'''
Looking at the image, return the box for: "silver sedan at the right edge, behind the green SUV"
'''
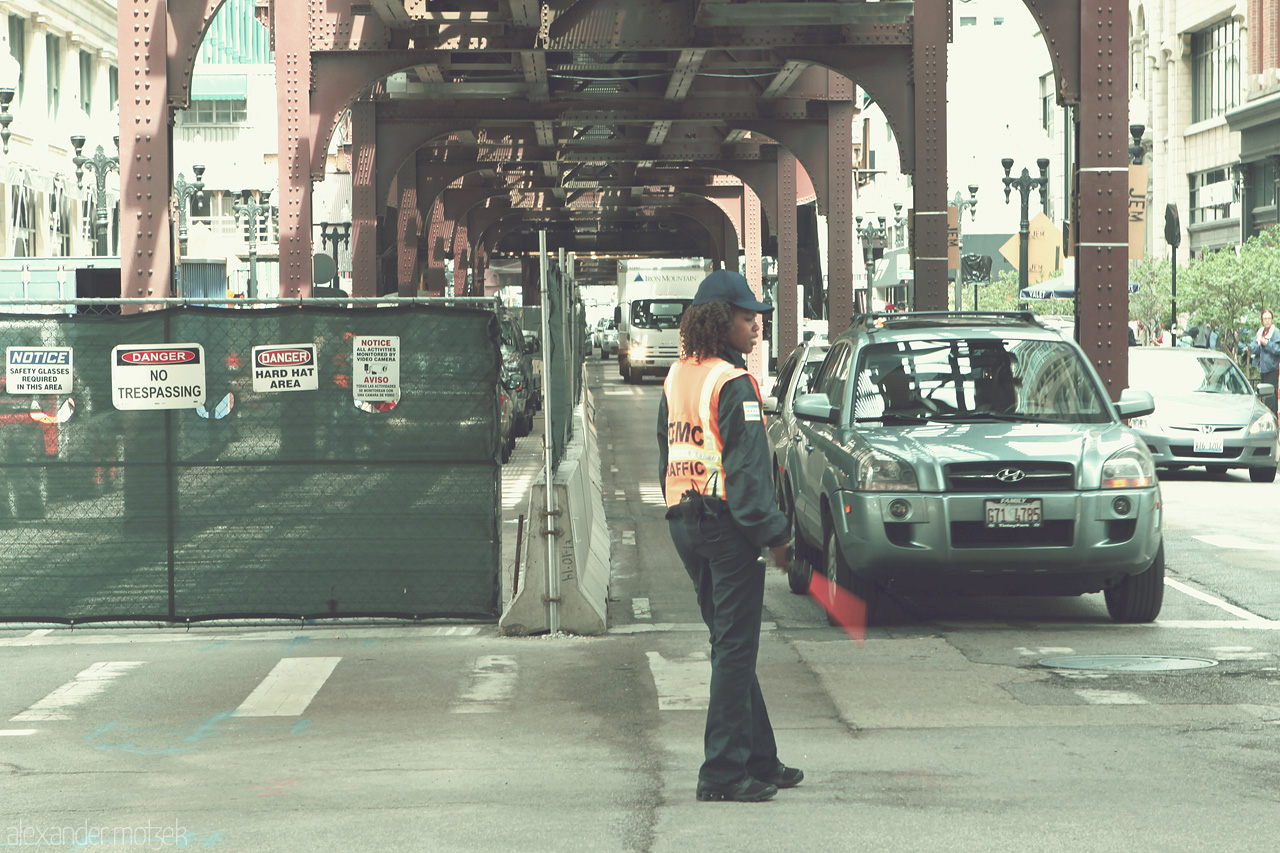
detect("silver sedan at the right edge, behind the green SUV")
[1129,347,1277,483]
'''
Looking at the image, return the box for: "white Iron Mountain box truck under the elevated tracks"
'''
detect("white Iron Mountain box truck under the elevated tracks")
[614,260,710,383]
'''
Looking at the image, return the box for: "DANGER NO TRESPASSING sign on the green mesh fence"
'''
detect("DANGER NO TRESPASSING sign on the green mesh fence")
[111,343,205,410]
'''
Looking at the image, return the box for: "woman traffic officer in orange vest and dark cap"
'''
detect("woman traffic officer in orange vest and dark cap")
[658,270,804,803]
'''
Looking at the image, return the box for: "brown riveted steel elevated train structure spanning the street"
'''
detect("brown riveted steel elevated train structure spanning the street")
[119,0,1128,398]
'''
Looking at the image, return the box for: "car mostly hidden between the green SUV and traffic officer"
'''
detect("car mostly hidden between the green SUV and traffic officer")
[764,337,828,594]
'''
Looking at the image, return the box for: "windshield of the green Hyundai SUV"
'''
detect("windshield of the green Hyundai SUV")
[851,338,1114,424]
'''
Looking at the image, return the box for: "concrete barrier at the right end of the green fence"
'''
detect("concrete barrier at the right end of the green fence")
[498,389,609,637]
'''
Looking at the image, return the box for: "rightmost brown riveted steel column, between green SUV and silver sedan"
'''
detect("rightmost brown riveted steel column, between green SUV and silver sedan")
[1075,1,1129,400]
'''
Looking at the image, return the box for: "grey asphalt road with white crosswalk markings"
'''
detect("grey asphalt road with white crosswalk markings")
[0,360,1280,853]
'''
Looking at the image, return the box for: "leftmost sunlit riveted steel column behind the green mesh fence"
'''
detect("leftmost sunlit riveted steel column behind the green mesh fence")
[116,0,173,311]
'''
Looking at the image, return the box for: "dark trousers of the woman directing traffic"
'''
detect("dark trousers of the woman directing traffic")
[669,519,778,784]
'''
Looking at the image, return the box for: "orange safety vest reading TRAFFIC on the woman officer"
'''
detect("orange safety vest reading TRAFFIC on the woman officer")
[663,359,760,507]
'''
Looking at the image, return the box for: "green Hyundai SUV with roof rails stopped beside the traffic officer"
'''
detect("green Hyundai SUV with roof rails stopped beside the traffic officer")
[791,311,1165,622]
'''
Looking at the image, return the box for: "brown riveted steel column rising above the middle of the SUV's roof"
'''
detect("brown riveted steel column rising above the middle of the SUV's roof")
[911,0,951,311]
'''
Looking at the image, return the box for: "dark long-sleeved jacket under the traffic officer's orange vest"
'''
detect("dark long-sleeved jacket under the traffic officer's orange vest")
[658,351,791,547]
